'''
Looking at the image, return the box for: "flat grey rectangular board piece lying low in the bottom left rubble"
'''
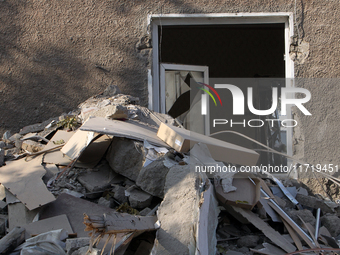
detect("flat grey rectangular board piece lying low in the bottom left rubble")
[23,214,73,239]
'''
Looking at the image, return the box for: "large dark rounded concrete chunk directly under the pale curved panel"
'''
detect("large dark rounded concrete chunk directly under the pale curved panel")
[106,137,145,181]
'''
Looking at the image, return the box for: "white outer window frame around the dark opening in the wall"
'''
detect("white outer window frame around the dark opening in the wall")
[148,12,294,156]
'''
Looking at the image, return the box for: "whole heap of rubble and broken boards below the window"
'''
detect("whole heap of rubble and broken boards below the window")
[0,86,340,255]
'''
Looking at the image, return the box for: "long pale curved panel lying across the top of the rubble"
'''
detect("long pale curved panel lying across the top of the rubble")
[80,118,169,148]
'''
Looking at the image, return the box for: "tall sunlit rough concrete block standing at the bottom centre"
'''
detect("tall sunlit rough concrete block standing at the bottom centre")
[153,165,199,255]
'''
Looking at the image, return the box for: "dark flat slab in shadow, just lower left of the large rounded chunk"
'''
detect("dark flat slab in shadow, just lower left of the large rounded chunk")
[77,161,122,192]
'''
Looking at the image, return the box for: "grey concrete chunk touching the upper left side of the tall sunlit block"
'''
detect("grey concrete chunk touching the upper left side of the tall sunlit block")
[136,157,169,198]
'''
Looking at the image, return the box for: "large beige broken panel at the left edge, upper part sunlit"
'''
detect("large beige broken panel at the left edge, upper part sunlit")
[0,156,55,210]
